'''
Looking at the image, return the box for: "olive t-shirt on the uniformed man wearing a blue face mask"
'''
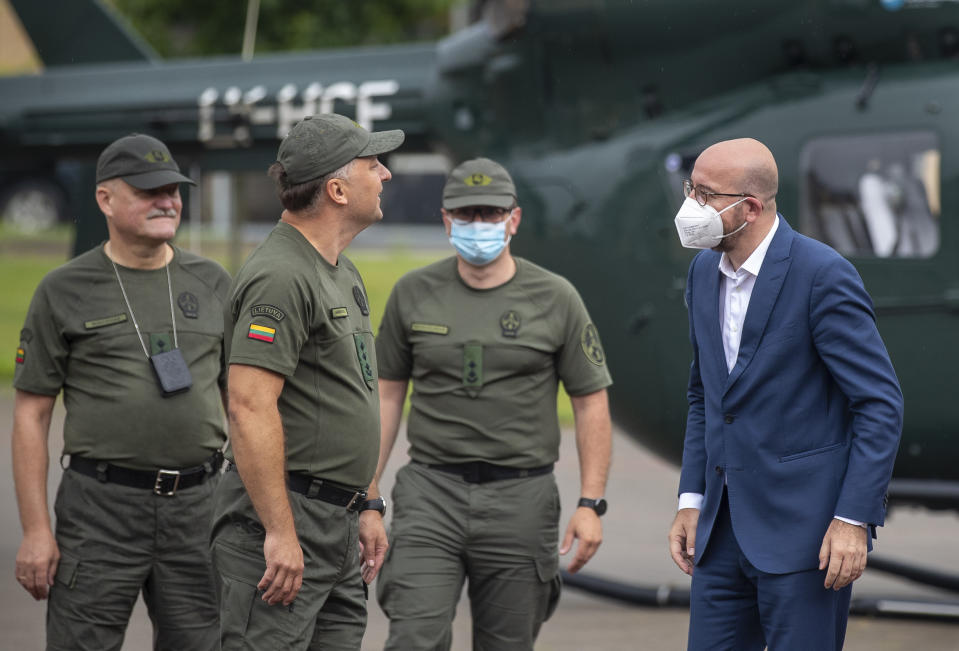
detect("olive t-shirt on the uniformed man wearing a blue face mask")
[376,257,612,468]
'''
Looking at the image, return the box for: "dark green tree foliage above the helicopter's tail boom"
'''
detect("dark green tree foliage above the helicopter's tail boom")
[107,0,465,57]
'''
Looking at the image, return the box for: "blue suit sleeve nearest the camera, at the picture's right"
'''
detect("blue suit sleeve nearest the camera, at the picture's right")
[809,258,903,526]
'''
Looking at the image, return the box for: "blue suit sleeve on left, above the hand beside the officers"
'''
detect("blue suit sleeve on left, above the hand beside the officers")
[679,256,706,494]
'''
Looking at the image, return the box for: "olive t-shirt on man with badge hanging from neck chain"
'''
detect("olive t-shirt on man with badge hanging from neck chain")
[13,245,230,469]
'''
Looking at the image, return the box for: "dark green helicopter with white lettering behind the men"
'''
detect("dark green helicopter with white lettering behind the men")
[0,0,959,509]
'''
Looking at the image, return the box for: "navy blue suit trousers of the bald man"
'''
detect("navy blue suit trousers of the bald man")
[689,490,852,651]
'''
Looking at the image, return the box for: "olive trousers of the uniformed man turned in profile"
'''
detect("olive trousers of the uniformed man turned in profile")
[212,472,366,651]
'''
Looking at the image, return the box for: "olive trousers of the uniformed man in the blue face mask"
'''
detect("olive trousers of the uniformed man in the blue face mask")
[377,463,560,651]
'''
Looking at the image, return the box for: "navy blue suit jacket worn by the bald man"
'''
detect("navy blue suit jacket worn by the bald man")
[679,215,903,574]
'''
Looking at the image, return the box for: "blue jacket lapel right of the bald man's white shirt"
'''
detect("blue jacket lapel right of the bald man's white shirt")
[720,215,795,393]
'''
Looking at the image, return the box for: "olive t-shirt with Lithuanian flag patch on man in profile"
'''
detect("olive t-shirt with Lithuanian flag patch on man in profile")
[226,222,380,488]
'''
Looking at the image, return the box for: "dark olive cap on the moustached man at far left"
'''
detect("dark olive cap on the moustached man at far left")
[97,133,196,190]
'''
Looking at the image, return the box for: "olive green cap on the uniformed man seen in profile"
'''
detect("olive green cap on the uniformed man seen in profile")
[276,113,406,185]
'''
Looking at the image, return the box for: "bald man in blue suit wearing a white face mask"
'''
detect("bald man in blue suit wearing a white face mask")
[669,139,902,651]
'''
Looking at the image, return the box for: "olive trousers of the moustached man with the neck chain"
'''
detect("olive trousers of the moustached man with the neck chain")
[47,470,218,651]
